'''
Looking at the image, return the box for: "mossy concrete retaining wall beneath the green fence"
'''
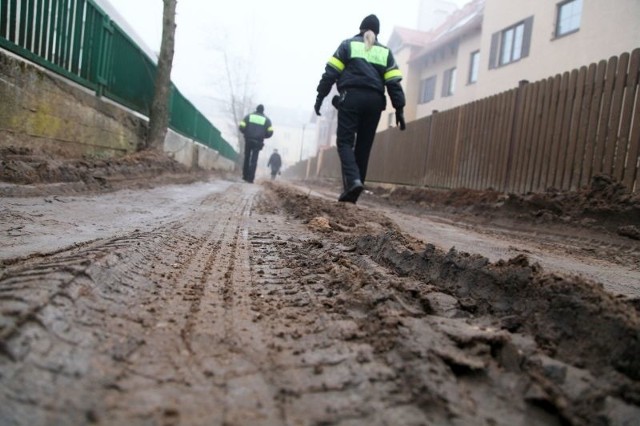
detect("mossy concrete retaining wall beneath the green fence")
[0,49,234,175]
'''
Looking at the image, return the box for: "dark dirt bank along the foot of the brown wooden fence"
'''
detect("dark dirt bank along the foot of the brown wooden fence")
[372,175,640,240]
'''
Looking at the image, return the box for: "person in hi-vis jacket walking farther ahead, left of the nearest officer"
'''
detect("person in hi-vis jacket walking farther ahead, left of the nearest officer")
[239,105,273,183]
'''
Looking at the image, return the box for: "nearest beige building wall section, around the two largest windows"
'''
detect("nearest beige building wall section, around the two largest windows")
[477,0,640,97]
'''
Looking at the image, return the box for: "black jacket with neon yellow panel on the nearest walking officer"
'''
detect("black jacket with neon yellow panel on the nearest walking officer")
[318,35,405,109]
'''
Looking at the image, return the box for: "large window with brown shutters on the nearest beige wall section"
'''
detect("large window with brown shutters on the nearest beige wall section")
[489,16,533,69]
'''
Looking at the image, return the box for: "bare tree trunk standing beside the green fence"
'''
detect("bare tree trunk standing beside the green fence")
[147,0,178,149]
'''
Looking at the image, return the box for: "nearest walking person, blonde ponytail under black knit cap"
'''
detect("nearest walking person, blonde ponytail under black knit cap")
[314,15,405,203]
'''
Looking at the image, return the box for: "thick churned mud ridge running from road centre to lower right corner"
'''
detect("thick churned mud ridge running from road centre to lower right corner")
[268,184,640,424]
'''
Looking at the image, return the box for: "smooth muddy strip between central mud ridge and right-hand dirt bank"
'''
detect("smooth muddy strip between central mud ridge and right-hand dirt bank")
[295,183,640,298]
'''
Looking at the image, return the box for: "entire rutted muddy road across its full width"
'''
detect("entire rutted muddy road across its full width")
[0,180,640,425]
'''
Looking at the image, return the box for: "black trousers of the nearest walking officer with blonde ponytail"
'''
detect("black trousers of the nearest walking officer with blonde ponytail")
[336,89,386,190]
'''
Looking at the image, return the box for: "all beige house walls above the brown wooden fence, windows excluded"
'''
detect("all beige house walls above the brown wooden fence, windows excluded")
[403,0,640,119]
